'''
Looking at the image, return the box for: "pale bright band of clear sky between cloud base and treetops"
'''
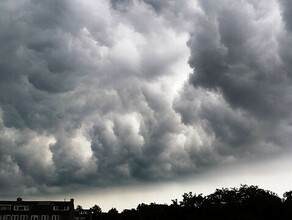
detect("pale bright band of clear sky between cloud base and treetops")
[12,152,292,212]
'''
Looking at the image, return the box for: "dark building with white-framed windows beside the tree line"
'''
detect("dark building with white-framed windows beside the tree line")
[0,198,74,220]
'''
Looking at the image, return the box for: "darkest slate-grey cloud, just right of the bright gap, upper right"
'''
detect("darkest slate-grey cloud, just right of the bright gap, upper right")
[188,1,291,117]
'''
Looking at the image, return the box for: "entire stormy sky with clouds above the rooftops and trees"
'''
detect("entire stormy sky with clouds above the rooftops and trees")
[0,0,292,211]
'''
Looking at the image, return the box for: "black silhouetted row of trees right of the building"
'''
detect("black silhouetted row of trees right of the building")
[82,185,292,220]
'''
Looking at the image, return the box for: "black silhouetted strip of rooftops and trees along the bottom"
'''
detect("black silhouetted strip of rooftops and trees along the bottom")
[0,185,292,220]
